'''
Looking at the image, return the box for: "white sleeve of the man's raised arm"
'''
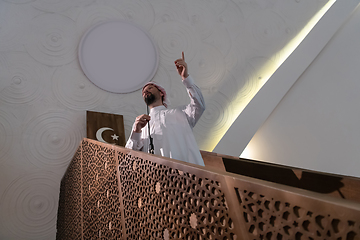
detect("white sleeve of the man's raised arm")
[183,76,205,128]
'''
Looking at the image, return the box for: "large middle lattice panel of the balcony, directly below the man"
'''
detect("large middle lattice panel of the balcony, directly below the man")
[118,153,235,239]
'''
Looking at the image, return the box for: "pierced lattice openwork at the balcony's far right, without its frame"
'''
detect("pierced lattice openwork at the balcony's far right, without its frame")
[235,188,360,240]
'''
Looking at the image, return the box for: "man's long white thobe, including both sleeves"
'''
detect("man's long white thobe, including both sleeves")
[125,76,205,166]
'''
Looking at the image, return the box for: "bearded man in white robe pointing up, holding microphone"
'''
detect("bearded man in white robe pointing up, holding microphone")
[125,53,205,166]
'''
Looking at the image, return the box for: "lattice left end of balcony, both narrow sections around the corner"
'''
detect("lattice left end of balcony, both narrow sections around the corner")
[57,141,122,239]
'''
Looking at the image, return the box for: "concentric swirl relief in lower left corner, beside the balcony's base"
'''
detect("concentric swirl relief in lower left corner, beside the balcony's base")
[1,171,60,239]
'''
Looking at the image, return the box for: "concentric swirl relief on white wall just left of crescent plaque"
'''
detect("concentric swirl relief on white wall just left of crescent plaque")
[22,111,85,168]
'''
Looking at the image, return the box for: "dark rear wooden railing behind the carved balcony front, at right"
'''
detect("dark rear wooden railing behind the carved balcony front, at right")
[201,151,360,203]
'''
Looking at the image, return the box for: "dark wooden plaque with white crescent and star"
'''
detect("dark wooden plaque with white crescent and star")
[86,111,125,147]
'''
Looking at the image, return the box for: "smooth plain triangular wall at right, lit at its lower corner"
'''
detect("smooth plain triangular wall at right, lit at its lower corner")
[242,2,360,177]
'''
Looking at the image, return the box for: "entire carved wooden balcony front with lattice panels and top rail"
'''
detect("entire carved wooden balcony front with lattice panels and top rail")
[57,139,360,240]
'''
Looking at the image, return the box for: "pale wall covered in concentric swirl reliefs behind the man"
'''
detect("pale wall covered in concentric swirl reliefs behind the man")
[0,0,327,240]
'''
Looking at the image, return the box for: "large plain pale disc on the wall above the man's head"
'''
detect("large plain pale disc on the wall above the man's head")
[79,20,159,93]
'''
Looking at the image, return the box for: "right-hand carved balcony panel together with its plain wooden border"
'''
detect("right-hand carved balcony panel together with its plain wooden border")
[229,180,360,240]
